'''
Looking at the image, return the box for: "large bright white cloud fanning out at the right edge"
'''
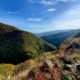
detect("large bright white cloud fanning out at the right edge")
[49,6,80,29]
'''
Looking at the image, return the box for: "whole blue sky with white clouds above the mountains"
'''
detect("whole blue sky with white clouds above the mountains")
[0,0,80,33]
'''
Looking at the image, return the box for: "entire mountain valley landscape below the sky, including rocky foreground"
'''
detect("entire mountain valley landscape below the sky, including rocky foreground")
[0,23,80,80]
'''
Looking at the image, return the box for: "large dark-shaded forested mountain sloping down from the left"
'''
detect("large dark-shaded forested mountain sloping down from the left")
[0,23,56,64]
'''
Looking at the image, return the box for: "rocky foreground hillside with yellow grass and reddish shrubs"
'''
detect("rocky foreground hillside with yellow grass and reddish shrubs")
[0,52,80,80]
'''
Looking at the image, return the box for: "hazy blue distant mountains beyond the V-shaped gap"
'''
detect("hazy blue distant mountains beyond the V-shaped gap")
[41,29,80,48]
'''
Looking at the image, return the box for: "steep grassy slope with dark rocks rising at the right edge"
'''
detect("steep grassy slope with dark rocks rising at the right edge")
[60,32,80,53]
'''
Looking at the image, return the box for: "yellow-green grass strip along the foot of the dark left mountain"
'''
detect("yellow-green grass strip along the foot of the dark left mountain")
[0,52,54,80]
